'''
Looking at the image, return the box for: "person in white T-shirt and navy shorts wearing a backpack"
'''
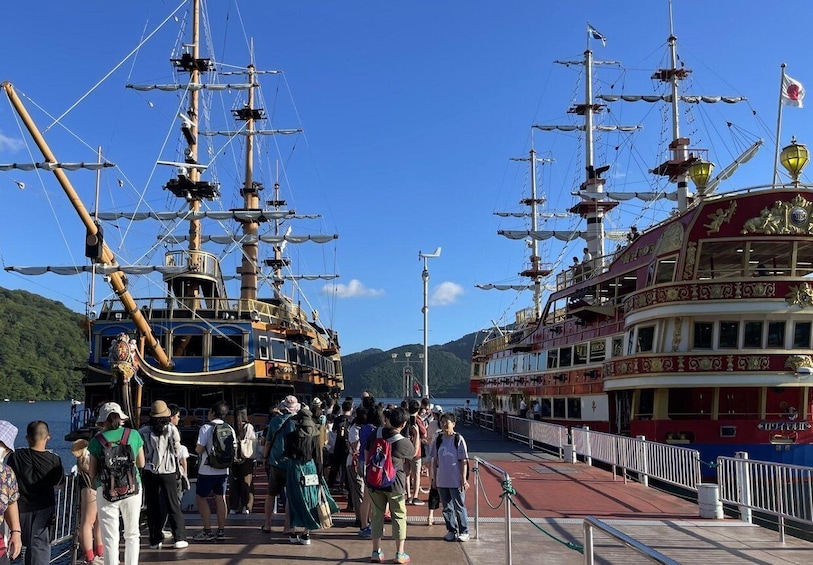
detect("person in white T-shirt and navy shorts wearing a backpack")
[192,400,237,541]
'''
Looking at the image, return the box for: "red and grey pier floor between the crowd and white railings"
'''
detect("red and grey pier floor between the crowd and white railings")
[140,426,813,565]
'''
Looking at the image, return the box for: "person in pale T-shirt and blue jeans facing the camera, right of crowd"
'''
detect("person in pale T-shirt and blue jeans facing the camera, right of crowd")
[431,412,469,542]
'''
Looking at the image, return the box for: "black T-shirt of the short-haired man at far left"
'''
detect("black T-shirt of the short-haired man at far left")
[7,448,65,512]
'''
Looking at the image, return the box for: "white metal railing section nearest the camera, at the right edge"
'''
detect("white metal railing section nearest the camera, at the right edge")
[717,452,813,543]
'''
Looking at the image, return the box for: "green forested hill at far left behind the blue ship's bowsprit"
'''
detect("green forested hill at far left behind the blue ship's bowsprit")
[0,288,88,400]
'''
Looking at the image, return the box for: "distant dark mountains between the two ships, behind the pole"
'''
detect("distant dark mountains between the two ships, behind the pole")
[342,333,477,398]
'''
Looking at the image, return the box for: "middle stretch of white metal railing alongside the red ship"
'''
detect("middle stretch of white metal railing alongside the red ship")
[570,426,701,492]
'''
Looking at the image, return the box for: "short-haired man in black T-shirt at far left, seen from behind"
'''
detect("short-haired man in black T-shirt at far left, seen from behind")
[8,420,65,565]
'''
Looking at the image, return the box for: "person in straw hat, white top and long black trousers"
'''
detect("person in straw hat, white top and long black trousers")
[139,400,189,549]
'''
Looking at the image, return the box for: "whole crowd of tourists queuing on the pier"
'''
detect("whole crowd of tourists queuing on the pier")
[0,393,469,565]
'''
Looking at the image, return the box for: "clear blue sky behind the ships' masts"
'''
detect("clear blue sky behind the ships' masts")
[0,0,813,353]
